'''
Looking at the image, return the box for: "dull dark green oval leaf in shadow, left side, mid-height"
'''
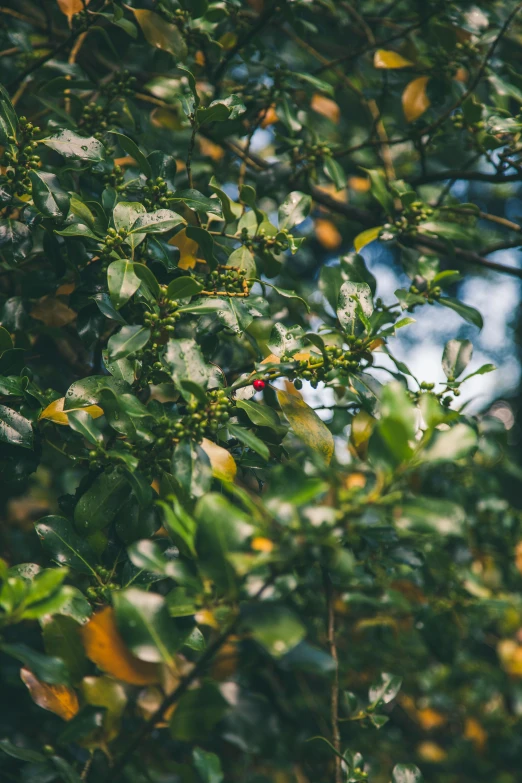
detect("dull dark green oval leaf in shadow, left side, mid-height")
[74,469,129,535]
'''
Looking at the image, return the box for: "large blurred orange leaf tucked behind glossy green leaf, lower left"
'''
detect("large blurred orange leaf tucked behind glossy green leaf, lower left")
[80,606,160,685]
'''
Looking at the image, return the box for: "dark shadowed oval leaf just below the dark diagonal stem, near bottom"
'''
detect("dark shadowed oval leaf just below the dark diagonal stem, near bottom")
[170,682,228,742]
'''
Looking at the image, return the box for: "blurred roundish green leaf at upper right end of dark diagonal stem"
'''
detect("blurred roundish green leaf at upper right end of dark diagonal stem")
[241,601,306,658]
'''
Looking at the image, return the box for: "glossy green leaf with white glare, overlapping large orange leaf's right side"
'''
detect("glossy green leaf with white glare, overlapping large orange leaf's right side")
[113,587,192,664]
